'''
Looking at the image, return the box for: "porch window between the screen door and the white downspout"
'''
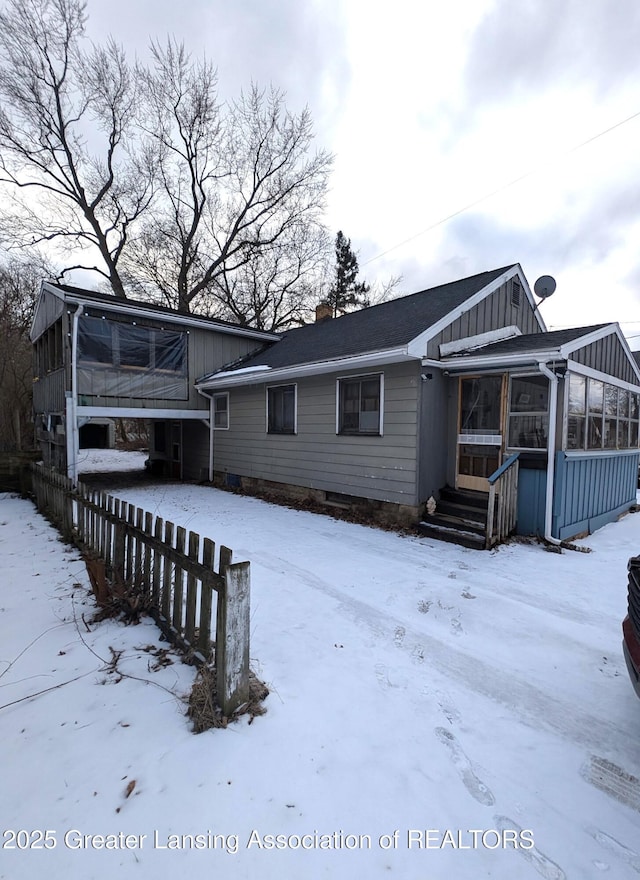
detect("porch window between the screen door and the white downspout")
[509,375,549,449]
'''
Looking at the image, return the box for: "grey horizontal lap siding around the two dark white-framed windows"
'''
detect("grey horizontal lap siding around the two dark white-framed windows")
[214,363,420,505]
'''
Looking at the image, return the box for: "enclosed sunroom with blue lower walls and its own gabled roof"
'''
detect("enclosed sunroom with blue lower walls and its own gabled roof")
[441,324,640,542]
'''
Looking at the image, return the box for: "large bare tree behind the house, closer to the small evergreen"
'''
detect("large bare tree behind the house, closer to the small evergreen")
[127,42,332,318]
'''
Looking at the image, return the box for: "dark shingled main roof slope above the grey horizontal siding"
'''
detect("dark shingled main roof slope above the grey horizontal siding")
[201,264,517,381]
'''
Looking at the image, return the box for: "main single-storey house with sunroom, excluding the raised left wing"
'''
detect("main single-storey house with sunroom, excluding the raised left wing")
[196,264,640,546]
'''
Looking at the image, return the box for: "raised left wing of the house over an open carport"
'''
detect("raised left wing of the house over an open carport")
[31,282,279,480]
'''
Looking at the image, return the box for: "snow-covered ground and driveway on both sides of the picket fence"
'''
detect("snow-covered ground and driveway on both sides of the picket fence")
[0,454,640,880]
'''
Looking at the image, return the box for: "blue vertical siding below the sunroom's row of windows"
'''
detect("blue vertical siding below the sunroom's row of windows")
[552,451,639,539]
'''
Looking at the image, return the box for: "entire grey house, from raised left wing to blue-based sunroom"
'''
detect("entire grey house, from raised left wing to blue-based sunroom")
[31,264,640,547]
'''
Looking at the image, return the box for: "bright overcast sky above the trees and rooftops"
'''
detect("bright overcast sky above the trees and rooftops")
[82,0,640,340]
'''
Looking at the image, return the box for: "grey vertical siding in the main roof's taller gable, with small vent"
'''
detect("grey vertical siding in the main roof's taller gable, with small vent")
[427,281,541,358]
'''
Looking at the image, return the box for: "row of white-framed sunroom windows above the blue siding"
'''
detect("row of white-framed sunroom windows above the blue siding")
[567,373,640,450]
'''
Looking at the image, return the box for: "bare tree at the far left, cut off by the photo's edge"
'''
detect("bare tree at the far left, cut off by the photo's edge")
[0,0,153,298]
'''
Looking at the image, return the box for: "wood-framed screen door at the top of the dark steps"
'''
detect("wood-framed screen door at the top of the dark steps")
[456,376,504,492]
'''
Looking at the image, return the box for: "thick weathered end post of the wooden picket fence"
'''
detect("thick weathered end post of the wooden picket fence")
[216,562,251,717]
